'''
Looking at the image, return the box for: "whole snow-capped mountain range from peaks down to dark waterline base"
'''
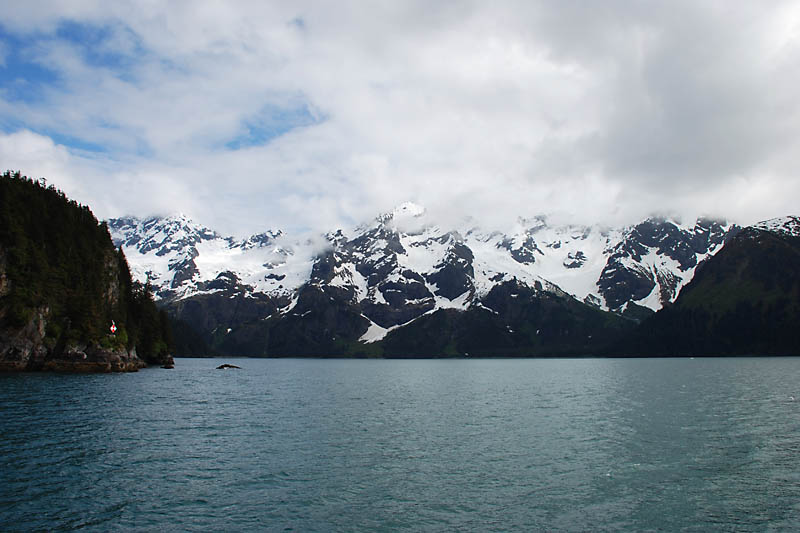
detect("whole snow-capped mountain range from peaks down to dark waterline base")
[108,203,764,356]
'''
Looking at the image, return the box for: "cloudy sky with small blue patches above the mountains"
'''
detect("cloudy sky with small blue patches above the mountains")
[0,0,800,236]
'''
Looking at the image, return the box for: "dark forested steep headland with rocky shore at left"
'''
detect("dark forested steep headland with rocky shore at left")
[0,172,171,371]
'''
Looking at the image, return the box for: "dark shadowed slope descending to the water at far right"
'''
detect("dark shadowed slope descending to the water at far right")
[618,217,800,356]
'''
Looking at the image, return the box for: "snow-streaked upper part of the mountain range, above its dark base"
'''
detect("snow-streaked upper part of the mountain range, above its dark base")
[109,203,738,352]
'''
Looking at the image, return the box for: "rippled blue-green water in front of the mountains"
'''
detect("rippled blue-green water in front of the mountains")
[0,358,800,532]
